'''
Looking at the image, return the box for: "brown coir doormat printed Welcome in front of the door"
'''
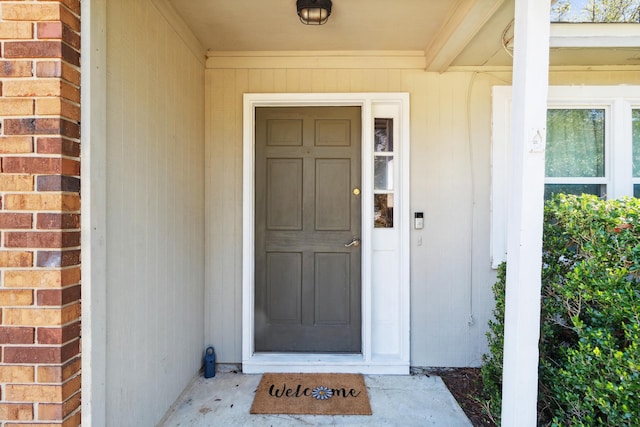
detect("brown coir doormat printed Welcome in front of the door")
[251,374,371,415]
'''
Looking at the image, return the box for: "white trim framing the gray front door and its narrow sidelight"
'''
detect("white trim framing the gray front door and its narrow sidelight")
[242,93,410,374]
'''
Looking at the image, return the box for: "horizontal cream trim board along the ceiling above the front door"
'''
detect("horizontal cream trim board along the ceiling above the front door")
[206,50,425,70]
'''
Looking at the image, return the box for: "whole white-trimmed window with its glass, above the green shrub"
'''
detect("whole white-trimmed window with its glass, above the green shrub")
[491,86,640,267]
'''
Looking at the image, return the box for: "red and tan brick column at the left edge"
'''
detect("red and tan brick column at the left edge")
[0,0,80,426]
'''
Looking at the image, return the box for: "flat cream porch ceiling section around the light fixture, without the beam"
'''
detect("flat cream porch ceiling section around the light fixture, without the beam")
[170,0,460,51]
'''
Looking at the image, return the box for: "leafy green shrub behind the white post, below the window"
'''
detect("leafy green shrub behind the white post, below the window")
[482,195,640,426]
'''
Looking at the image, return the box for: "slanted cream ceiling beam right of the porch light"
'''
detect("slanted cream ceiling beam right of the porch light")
[425,0,504,72]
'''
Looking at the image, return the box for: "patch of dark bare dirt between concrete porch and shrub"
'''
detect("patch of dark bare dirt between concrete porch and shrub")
[434,368,496,427]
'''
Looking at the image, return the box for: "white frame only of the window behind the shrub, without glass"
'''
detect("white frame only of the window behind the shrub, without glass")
[491,85,640,268]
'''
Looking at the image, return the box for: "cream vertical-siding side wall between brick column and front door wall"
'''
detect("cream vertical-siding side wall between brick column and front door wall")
[106,0,204,425]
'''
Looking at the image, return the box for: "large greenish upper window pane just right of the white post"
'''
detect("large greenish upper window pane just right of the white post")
[545,109,605,177]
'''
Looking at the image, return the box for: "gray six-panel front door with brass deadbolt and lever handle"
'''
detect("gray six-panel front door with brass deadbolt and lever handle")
[255,107,361,353]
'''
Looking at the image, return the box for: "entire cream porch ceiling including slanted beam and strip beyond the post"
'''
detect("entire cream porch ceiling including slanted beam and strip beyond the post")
[168,0,640,71]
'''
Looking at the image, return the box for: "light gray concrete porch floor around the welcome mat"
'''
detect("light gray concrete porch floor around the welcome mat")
[161,372,471,427]
